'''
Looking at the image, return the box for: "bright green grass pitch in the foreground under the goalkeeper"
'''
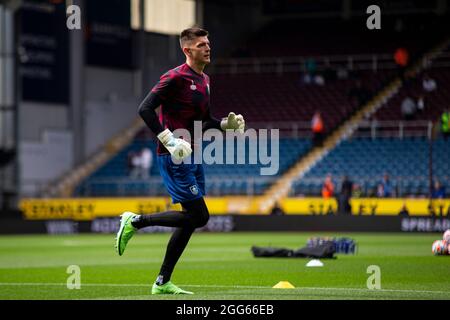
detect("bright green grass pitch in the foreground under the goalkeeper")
[0,233,450,300]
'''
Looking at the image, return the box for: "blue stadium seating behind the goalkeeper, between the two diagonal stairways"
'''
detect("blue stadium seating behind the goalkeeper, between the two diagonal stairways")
[76,135,311,196]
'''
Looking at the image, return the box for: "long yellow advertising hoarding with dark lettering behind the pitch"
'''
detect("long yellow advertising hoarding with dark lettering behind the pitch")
[20,197,450,221]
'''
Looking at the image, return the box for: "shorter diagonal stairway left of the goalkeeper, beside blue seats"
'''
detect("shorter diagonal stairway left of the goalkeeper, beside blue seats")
[43,118,145,197]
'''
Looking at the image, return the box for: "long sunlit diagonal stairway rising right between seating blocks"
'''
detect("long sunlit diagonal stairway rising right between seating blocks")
[253,39,450,213]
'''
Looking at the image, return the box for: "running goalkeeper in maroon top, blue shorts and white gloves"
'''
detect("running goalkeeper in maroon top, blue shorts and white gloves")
[116,28,245,294]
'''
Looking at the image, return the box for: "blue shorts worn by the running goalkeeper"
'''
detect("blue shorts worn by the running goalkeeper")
[157,154,205,203]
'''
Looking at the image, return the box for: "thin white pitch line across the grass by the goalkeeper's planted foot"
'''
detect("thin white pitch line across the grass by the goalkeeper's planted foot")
[0,282,450,294]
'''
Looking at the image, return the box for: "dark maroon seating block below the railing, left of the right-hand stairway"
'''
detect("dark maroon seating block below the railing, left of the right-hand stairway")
[211,71,392,132]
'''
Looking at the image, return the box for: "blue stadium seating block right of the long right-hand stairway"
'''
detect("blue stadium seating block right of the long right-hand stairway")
[292,137,450,197]
